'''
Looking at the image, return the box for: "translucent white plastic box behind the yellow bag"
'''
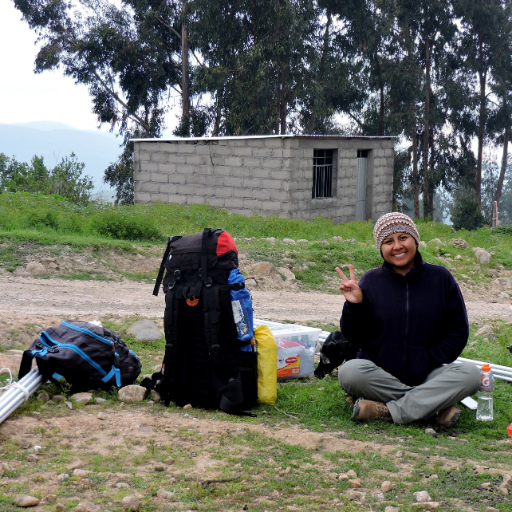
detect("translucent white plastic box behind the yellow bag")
[254,318,322,380]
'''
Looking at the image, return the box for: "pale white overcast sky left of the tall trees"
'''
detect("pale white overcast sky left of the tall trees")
[0,0,180,131]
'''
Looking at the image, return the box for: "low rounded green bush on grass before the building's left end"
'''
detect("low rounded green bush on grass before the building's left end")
[92,210,164,242]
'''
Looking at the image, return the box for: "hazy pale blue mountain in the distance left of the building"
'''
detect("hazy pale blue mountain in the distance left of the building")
[0,121,122,197]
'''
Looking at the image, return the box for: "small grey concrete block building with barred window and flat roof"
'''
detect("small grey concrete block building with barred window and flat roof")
[134,135,396,223]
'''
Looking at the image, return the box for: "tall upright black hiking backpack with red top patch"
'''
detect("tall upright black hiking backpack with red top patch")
[147,228,258,414]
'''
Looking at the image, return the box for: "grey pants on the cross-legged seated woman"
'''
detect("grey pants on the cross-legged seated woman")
[338,359,480,423]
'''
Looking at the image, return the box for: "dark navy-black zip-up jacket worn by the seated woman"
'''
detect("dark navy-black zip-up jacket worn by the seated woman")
[341,252,469,386]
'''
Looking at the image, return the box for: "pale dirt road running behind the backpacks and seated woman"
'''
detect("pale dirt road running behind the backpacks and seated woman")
[0,274,512,323]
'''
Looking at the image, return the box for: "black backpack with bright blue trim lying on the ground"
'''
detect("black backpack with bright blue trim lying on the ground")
[19,321,141,391]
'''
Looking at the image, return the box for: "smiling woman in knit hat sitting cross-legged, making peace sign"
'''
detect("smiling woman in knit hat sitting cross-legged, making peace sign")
[336,212,480,427]
